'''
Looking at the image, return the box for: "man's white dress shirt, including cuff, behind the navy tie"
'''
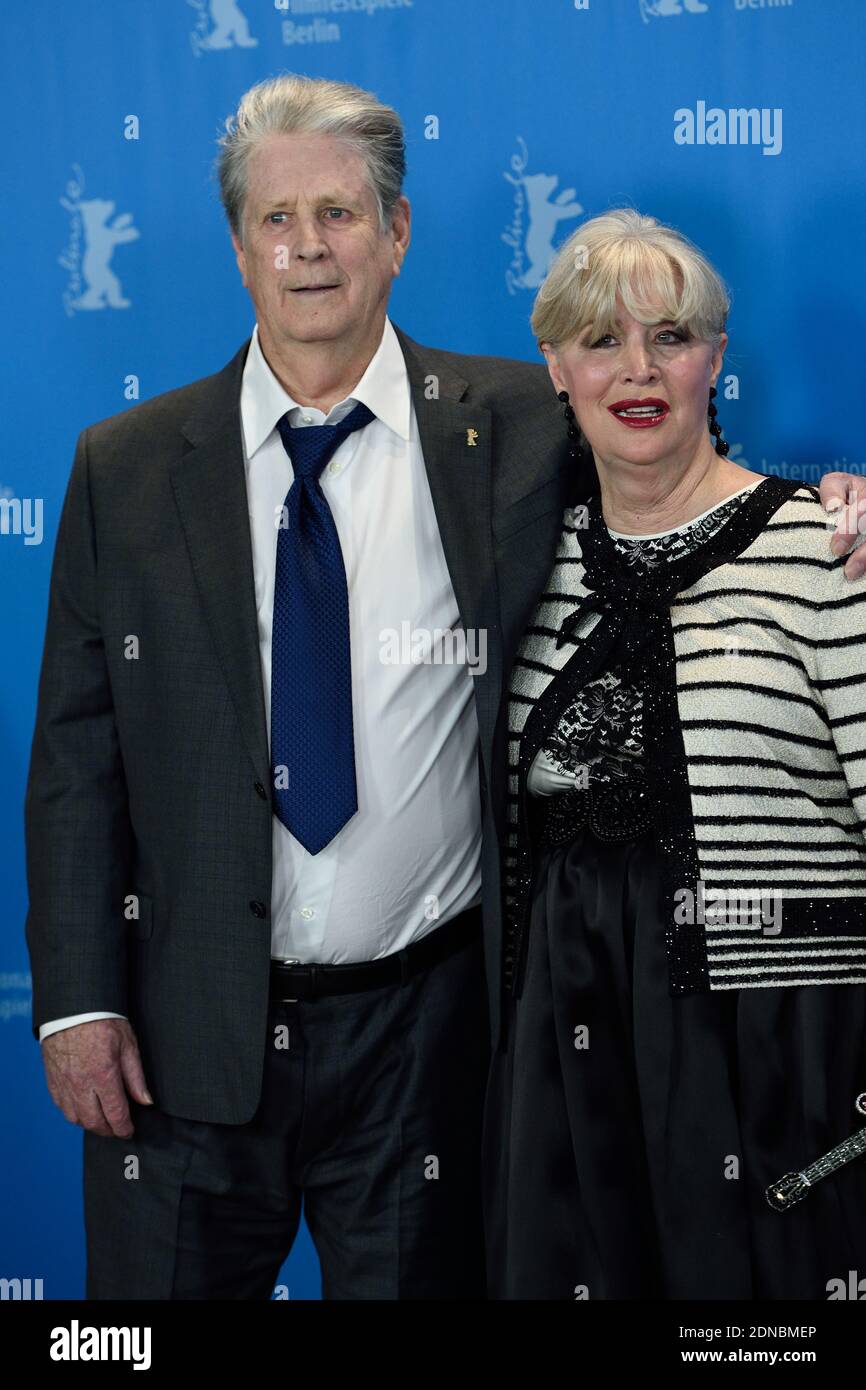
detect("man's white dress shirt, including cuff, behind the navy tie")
[39,320,481,1041]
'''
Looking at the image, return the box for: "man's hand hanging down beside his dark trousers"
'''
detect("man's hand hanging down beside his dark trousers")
[40,1019,153,1138]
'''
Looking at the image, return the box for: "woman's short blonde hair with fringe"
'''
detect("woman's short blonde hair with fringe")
[530,207,731,348]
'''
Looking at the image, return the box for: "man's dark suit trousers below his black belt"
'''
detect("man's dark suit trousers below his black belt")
[83,917,489,1300]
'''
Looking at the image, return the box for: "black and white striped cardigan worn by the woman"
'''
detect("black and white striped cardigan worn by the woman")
[503,478,866,994]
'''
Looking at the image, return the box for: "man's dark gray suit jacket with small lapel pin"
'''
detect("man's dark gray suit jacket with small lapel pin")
[25,329,584,1125]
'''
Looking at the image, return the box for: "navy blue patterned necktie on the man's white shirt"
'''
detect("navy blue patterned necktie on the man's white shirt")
[271,403,375,855]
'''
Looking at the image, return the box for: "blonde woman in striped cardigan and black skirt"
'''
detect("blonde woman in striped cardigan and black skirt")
[484,210,866,1298]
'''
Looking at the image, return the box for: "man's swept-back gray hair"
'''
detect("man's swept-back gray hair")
[217,72,406,242]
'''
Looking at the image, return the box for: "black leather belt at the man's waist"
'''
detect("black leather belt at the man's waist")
[271,908,481,1004]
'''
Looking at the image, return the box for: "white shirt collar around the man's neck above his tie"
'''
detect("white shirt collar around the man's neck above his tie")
[240,318,410,459]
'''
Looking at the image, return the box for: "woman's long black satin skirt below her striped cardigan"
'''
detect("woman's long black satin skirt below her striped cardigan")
[484,831,866,1300]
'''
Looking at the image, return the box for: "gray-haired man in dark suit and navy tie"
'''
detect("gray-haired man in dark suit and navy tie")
[26,76,853,1298]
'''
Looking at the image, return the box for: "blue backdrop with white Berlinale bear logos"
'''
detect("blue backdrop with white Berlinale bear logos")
[0,0,866,1298]
